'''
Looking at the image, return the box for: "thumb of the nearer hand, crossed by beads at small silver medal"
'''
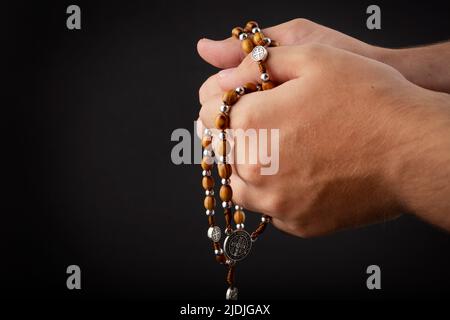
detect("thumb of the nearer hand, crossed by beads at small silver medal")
[216,46,308,91]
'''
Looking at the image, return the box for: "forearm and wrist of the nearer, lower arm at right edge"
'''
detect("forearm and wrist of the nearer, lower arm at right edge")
[392,90,450,231]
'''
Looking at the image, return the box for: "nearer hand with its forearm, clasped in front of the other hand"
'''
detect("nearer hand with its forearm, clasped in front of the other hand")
[199,19,450,237]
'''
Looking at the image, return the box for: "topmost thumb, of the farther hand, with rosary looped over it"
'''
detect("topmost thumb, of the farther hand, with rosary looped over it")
[197,19,306,69]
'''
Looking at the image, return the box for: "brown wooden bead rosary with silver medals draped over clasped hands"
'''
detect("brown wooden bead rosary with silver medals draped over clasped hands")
[201,21,278,300]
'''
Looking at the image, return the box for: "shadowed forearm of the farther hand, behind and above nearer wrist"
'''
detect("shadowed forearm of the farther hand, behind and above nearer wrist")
[378,41,450,93]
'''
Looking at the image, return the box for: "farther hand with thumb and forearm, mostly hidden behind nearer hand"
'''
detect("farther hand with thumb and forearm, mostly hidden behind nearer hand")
[197,18,450,93]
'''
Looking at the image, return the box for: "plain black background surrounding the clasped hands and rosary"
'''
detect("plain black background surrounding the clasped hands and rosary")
[6,0,450,300]
